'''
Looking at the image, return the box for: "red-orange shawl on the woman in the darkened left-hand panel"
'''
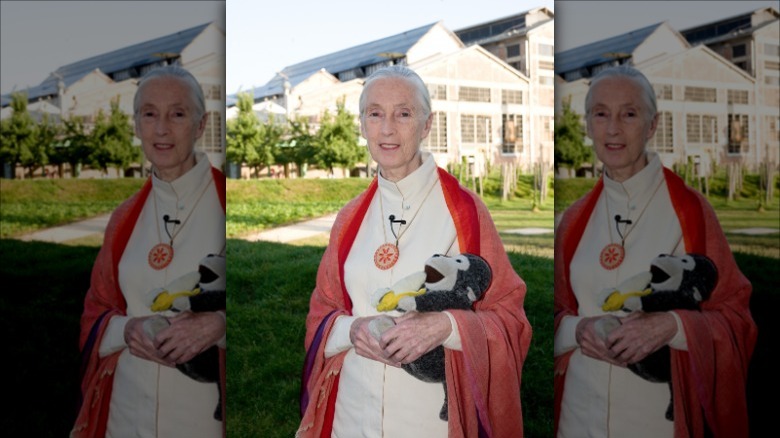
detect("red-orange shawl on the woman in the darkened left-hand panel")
[71,167,226,438]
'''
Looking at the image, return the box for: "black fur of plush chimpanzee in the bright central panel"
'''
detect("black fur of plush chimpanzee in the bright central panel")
[399,254,492,421]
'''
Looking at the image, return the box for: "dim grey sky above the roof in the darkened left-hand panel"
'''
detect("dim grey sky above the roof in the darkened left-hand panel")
[0,0,225,94]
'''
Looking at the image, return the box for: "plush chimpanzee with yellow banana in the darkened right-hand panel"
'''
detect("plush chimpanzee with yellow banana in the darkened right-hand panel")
[596,254,718,421]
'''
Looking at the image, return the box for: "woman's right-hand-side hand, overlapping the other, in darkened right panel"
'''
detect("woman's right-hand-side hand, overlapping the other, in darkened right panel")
[606,312,677,364]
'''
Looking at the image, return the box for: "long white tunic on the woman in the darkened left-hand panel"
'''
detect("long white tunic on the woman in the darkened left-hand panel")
[100,153,225,438]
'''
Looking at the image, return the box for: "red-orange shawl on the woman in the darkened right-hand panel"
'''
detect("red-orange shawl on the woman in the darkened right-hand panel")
[553,168,757,438]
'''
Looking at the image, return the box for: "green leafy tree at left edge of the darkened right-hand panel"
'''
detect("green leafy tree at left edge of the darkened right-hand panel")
[555,99,593,176]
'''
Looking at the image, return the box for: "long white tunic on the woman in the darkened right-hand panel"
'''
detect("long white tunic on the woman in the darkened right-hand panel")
[555,153,686,438]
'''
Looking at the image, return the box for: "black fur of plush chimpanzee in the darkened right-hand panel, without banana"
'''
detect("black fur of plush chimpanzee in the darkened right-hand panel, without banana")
[628,254,718,421]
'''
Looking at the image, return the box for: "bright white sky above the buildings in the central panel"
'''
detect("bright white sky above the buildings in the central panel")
[226,0,554,94]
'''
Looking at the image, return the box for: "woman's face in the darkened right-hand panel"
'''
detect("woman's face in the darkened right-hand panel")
[587,77,658,182]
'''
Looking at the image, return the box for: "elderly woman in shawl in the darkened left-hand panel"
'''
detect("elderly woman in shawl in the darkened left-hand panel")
[71,66,225,437]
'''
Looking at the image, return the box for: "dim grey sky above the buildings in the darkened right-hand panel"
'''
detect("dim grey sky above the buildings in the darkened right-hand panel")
[555,0,778,52]
